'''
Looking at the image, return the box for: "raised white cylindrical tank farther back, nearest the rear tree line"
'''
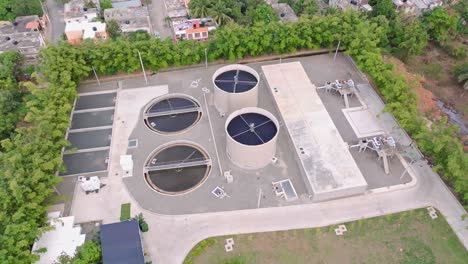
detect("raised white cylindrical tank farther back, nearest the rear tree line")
[213,64,260,115]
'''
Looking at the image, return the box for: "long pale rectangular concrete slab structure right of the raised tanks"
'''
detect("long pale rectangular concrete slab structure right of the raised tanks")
[262,62,367,201]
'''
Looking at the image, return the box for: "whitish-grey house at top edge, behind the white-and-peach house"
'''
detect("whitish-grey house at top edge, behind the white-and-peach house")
[63,0,100,24]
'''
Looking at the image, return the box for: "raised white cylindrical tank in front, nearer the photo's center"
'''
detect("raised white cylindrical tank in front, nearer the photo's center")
[225,107,279,169]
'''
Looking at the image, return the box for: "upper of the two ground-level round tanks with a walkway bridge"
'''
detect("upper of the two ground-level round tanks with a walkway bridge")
[144,94,202,134]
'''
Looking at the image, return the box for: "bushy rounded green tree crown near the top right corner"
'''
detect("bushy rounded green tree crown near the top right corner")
[422,7,457,43]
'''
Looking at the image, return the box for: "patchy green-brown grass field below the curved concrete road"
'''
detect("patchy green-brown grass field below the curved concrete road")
[184,209,468,264]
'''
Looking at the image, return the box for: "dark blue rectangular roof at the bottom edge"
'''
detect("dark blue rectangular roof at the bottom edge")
[101,220,145,264]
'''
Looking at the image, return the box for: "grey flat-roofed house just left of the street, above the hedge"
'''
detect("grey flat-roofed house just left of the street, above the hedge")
[104,7,153,34]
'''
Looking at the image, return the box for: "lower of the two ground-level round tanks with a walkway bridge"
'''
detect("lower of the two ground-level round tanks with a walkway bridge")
[144,142,211,195]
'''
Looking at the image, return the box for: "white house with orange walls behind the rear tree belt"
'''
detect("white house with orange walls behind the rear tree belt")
[172,18,216,41]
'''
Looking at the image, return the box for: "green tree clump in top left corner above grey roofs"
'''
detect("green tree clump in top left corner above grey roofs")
[0,0,42,21]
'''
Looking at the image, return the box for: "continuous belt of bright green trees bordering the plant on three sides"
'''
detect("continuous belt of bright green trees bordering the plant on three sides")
[0,0,468,264]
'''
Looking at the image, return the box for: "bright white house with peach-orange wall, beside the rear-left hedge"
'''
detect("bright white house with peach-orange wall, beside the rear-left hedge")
[65,21,107,44]
